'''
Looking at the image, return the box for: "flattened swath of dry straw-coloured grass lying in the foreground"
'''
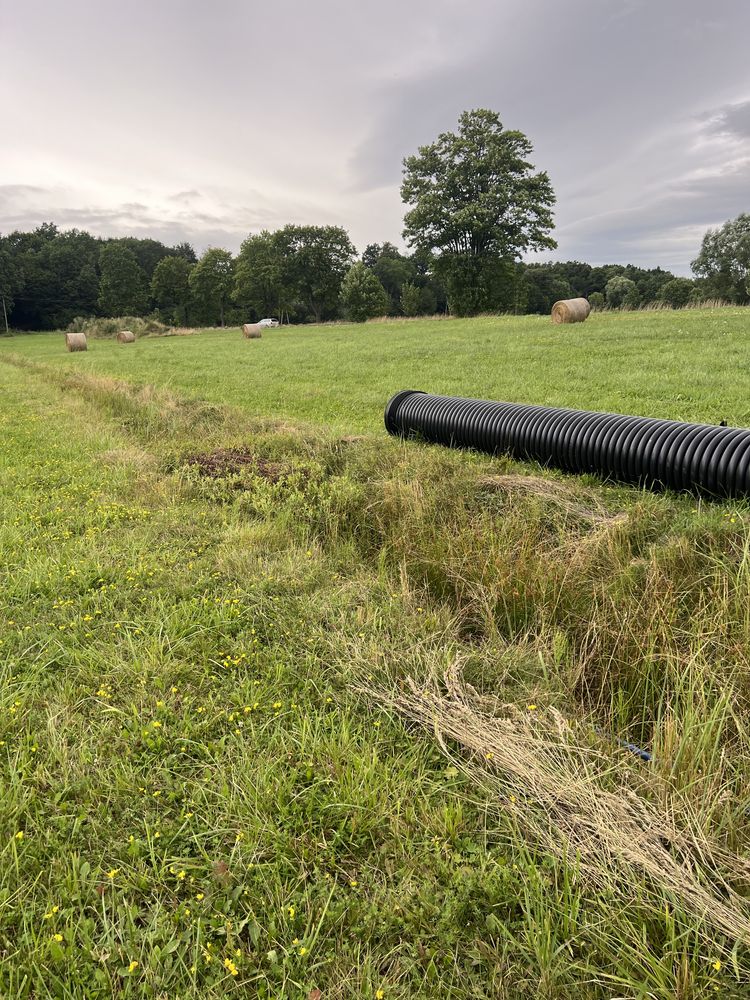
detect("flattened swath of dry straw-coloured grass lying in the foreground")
[361,664,750,943]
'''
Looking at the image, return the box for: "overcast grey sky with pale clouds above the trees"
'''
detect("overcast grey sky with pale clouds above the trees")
[0,0,750,273]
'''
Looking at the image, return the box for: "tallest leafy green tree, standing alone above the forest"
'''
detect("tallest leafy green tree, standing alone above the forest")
[401,109,557,314]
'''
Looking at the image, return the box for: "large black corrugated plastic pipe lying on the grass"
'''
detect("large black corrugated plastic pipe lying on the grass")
[385,389,750,497]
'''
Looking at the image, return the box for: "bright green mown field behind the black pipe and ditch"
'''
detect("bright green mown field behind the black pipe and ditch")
[5,308,750,432]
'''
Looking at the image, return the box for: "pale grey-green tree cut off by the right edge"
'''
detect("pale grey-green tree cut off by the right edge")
[691,212,750,303]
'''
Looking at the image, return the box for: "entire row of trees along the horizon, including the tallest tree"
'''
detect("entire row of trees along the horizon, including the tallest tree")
[0,109,750,330]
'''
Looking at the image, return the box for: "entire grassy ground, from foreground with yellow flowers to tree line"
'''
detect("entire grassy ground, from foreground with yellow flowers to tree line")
[0,309,750,1000]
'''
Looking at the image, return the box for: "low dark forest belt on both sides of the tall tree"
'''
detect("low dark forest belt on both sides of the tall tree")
[0,223,748,330]
